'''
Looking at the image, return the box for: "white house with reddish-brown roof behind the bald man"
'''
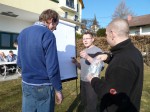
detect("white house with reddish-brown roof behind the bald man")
[128,14,150,36]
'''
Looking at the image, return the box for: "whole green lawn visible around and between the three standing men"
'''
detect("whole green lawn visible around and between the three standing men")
[0,66,150,112]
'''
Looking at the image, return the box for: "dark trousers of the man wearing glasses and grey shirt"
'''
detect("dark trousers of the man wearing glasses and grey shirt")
[80,81,98,112]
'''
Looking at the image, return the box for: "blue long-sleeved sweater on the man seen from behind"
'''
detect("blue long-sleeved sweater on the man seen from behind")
[17,25,62,91]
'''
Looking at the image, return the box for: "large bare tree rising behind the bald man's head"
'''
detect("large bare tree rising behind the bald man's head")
[112,0,134,19]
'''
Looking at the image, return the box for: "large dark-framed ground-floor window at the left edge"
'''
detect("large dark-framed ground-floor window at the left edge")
[0,32,19,49]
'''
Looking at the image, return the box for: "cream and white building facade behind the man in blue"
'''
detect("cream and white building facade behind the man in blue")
[0,0,84,51]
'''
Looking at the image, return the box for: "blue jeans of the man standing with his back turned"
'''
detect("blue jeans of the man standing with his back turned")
[22,83,55,112]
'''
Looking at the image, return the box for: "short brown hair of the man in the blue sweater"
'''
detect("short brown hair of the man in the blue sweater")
[39,9,59,23]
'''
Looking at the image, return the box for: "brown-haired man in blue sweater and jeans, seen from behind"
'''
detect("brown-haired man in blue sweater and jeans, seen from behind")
[17,9,63,112]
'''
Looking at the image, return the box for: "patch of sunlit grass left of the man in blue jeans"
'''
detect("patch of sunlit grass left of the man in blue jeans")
[0,79,22,112]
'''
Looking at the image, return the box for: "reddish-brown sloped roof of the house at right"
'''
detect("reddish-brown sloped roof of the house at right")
[128,14,150,27]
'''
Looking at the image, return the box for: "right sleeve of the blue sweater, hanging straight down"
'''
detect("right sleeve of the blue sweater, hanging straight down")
[43,34,62,91]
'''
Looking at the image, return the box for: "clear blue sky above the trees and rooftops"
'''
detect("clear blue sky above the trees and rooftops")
[82,0,150,28]
